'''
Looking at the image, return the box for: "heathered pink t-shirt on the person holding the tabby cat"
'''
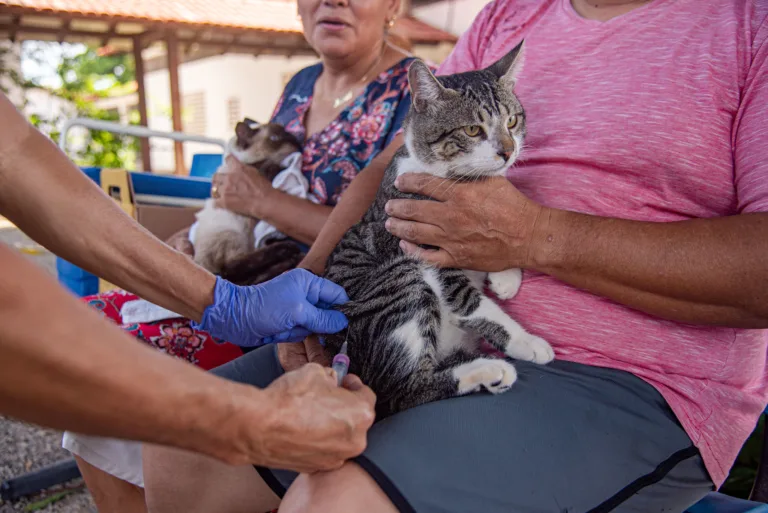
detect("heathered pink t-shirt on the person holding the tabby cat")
[439,0,768,486]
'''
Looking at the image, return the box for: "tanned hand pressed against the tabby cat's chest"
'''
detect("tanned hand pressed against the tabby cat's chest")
[386,173,545,272]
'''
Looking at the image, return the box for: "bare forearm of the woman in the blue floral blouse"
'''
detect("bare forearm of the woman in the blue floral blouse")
[254,190,333,245]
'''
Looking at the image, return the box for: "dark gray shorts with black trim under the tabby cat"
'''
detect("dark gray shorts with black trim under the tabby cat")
[214,347,713,513]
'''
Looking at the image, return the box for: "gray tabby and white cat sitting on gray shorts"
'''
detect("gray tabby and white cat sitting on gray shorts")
[326,43,554,415]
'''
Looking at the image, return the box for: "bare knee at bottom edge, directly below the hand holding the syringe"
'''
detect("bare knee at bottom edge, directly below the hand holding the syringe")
[280,462,397,513]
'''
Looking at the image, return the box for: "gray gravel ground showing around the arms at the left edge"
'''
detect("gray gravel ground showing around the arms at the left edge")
[0,223,96,513]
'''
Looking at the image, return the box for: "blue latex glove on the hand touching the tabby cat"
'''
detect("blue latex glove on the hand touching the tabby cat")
[192,269,349,347]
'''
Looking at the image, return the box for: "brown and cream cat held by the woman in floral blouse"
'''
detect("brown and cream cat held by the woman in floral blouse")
[193,118,301,281]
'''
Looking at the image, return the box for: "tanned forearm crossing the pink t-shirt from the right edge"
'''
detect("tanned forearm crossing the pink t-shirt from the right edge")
[532,210,768,328]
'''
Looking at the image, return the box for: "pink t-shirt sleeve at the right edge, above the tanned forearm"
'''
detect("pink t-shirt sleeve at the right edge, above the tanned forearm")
[733,20,768,213]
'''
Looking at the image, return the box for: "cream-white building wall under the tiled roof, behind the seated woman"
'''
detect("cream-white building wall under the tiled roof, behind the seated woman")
[145,54,316,172]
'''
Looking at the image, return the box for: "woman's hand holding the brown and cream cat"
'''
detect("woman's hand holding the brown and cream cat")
[212,156,274,219]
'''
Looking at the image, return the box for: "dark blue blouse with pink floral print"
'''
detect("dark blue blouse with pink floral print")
[272,58,413,206]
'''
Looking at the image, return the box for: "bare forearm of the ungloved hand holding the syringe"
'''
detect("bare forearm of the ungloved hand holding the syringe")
[0,245,260,457]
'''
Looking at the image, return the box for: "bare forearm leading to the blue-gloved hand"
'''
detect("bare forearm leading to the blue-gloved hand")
[0,96,215,320]
